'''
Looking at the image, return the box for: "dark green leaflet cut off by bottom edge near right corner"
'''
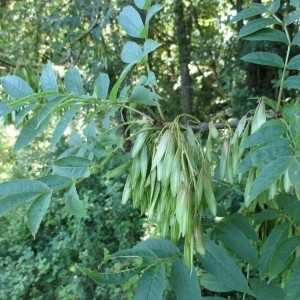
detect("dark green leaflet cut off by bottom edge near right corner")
[250,278,284,300]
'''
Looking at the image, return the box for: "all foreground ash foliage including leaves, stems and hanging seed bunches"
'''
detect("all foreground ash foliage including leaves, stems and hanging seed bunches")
[0,0,300,299]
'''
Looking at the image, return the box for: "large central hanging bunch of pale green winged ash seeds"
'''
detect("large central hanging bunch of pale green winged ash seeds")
[122,119,216,266]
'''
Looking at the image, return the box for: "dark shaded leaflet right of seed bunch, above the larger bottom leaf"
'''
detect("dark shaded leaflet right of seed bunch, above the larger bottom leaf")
[215,220,258,267]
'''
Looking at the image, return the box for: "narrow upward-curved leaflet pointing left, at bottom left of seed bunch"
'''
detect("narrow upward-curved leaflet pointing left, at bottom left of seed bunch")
[80,266,146,284]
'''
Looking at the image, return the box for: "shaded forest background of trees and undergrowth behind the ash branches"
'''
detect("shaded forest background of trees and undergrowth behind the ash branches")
[0,0,296,300]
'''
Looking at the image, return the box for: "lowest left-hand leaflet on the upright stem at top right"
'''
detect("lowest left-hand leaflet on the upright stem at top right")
[242,51,284,68]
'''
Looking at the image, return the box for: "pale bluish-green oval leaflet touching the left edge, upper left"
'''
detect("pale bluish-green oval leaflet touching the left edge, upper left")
[1,75,34,99]
